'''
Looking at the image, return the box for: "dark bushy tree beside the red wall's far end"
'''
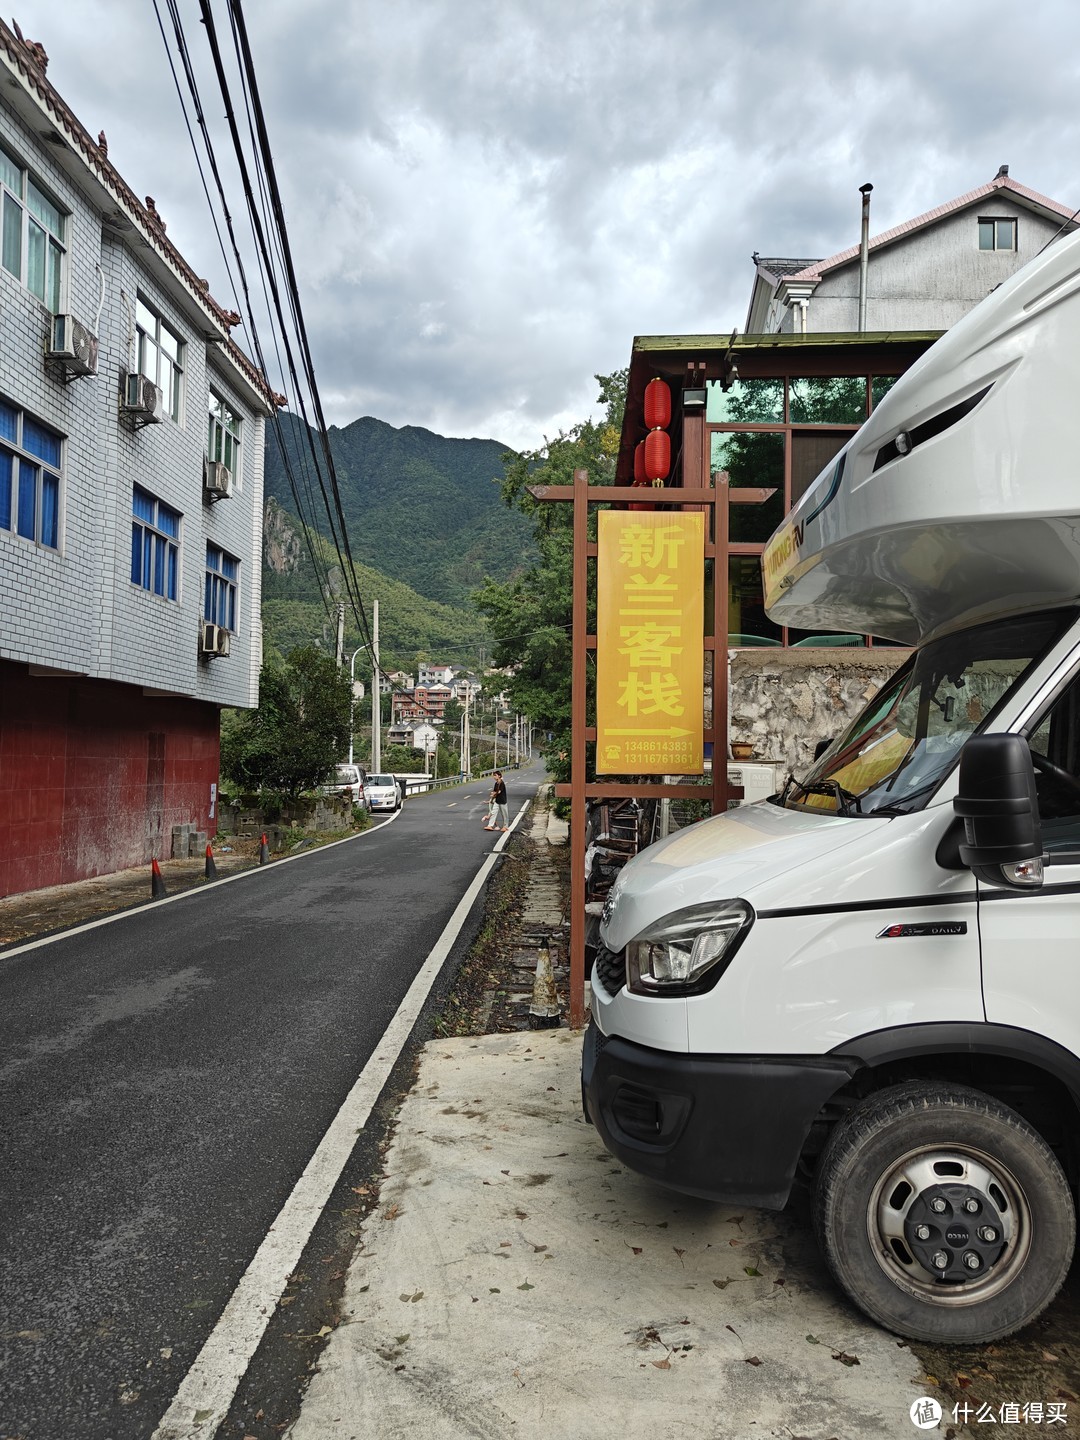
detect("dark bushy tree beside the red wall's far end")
[222,645,353,799]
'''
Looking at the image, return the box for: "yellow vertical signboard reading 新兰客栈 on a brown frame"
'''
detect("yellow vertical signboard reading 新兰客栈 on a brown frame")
[596,510,706,775]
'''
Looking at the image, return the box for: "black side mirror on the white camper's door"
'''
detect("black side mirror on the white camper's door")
[952,734,1044,890]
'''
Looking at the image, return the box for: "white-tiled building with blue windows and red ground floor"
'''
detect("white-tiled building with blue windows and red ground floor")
[0,23,274,894]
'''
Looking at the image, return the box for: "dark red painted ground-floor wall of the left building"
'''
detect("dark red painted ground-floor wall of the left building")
[0,660,219,896]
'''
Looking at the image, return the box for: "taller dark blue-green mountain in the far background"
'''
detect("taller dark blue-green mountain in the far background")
[265,415,536,608]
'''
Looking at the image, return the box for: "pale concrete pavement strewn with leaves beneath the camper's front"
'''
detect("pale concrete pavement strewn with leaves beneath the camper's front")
[289,1030,926,1440]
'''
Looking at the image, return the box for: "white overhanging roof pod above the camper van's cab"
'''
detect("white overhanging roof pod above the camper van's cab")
[762,232,1080,645]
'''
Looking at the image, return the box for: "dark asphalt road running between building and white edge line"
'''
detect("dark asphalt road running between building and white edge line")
[0,769,541,1440]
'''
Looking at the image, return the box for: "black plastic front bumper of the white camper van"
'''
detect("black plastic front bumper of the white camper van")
[582,1024,858,1210]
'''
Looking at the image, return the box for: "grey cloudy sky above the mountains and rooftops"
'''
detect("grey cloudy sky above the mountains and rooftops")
[13,0,1080,448]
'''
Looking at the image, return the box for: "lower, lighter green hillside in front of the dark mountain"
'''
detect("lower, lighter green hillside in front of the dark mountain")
[262,498,490,675]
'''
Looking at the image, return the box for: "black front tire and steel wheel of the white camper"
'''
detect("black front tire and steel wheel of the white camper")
[814,1083,1076,1345]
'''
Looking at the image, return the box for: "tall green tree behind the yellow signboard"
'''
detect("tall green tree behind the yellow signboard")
[475,370,628,780]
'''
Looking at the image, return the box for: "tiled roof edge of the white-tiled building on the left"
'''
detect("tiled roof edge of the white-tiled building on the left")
[0,20,285,406]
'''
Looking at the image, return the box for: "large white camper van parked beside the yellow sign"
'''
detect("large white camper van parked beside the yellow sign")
[582,218,1080,1344]
